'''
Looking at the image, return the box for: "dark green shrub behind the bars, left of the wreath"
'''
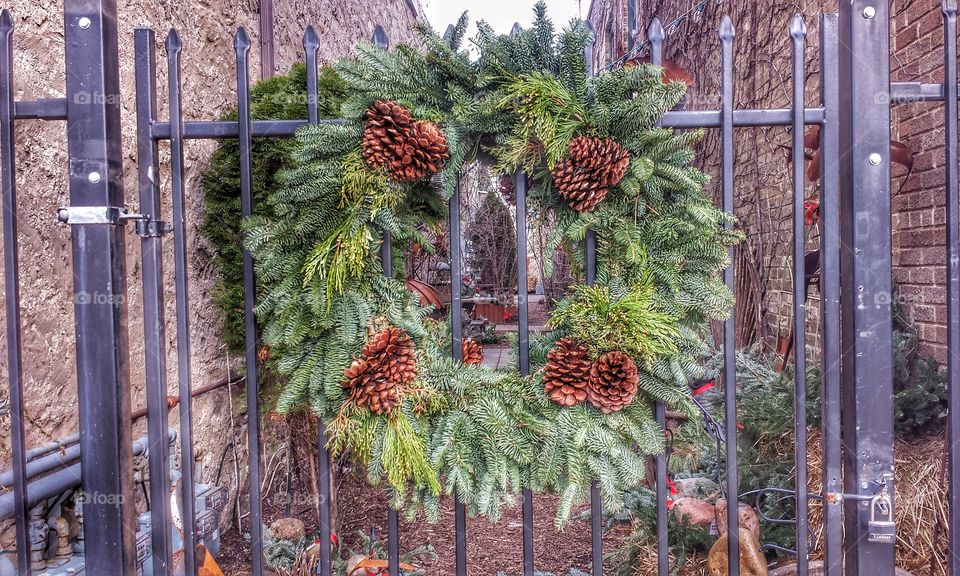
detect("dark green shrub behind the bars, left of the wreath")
[200,64,345,354]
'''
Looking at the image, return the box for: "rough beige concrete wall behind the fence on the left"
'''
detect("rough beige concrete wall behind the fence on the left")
[0,0,415,512]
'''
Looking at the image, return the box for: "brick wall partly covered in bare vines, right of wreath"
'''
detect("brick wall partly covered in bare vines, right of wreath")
[590,0,946,361]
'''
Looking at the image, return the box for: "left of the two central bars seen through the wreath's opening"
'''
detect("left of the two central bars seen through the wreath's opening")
[447,179,467,576]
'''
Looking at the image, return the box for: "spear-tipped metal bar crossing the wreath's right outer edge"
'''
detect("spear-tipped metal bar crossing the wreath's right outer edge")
[720,16,740,576]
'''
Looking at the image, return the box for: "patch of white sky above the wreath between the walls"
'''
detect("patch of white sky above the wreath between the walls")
[420,0,590,39]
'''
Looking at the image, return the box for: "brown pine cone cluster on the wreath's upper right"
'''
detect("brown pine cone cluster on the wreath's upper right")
[553,136,630,212]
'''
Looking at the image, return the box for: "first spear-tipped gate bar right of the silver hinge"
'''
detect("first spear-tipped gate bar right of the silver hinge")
[164,30,197,574]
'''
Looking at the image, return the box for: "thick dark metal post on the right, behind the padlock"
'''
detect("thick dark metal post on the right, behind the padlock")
[839,0,894,576]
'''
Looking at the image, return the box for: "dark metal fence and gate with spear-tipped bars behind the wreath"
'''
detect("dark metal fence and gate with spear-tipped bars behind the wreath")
[0,0,960,576]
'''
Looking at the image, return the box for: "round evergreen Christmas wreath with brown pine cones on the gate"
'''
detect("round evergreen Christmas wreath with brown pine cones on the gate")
[247,4,739,527]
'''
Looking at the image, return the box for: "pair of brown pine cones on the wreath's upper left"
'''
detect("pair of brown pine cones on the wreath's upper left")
[363,100,450,182]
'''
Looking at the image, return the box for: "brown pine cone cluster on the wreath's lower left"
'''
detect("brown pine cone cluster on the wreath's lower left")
[340,326,417,414]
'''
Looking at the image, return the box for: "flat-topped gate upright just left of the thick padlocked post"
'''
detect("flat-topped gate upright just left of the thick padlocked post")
[820,14,843,576]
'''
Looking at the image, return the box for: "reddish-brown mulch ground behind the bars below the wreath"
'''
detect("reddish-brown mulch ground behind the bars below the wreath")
[218,466,629,576]
